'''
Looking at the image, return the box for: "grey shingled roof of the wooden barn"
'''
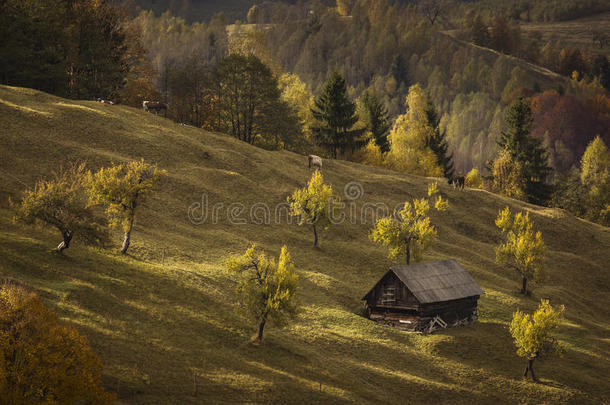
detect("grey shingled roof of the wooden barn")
[367,259,485,304]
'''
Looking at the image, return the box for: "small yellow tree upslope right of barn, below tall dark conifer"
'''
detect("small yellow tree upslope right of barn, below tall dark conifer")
[496,207,547,294]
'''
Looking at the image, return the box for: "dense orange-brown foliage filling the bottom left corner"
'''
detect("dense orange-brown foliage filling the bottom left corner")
[0,283,113,405]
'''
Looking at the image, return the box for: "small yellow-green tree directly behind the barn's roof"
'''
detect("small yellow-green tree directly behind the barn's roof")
[370,183,448,265]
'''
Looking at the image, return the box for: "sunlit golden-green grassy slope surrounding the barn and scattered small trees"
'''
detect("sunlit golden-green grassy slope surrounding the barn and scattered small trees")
[0,87,610,404]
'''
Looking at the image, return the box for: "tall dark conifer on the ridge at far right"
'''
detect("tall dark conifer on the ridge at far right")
[498,97,552,205]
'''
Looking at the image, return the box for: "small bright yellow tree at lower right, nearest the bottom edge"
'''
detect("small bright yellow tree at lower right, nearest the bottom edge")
[510,300,565,381]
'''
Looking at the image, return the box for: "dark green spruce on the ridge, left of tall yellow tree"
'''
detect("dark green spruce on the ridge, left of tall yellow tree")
[311,72,365,159]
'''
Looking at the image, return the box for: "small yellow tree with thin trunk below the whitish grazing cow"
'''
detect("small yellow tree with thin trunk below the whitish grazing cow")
[288,171,335,247]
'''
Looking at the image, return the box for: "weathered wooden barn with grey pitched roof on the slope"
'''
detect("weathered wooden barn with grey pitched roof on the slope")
[363,259,484,332]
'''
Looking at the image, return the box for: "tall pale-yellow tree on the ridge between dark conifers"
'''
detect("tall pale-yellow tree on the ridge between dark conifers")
[386,84,443,177]
